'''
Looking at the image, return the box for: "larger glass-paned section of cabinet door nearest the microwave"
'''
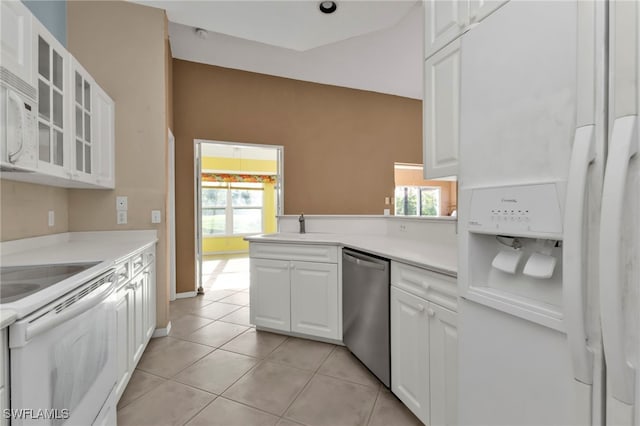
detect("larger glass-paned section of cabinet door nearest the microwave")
[37,34,66,167]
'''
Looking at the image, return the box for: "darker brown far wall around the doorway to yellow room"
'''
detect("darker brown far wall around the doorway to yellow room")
[173,60,422,292]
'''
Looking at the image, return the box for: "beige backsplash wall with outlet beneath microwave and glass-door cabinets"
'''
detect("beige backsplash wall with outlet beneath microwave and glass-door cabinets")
[0,179,69,241]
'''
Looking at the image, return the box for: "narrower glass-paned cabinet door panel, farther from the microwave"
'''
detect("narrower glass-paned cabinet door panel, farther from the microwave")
[73,68,93,174]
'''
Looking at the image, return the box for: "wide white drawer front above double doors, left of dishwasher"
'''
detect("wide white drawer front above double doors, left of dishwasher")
[249,243,338,263]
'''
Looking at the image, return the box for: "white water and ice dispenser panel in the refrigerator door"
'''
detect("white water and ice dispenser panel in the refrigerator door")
[460,182,564,329]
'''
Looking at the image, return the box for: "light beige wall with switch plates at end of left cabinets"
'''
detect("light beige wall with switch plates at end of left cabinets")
[67,1,169,327]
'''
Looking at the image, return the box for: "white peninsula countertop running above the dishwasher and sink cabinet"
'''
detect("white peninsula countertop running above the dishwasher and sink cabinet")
[245,232,458,277]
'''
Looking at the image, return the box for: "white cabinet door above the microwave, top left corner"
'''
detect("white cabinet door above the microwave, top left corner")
[0,0,36,87]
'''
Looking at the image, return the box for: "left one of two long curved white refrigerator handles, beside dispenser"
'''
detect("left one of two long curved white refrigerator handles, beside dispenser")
[562,125,595,385]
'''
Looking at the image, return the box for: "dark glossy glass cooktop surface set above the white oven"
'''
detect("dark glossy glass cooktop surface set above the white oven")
[0,262,100,303]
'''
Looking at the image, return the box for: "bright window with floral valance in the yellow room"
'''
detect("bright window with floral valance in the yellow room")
[202,182,264,236]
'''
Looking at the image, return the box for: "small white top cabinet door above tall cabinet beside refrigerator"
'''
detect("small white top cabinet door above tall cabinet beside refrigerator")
[424,0,469,58]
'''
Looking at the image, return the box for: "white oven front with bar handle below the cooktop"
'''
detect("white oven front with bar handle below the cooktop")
[9,270,116,426]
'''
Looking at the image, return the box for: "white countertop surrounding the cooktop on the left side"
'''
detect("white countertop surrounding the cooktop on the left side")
[0,230,157,326]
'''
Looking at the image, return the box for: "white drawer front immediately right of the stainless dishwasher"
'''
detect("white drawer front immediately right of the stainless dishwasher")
[391,262,458,311]
